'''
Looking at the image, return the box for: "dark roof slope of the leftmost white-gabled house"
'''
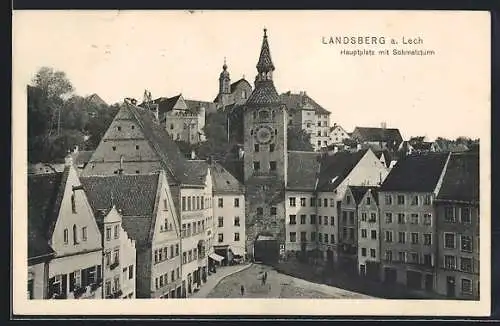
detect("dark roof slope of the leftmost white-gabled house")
[27,168,69,258]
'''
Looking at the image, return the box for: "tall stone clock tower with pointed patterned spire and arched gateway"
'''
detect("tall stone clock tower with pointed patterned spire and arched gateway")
[243,29,288,258]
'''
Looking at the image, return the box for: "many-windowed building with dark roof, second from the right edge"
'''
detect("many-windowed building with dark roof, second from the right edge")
[379,153,449,291]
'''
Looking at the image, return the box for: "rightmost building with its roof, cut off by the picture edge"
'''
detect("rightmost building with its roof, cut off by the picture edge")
[434,153,480,300]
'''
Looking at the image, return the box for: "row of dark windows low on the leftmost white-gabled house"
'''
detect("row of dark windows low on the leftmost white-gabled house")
[48,265,101,298]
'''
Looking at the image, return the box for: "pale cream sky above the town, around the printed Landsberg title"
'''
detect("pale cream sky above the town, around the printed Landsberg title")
[13,10,491,139]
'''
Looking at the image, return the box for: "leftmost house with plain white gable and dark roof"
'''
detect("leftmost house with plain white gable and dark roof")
[28,161,102,299]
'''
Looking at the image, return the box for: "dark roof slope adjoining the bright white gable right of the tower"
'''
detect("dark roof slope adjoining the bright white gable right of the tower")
[317,149,368,191]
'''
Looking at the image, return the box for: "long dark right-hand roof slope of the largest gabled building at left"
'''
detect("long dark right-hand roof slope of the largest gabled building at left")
[127,105,189,184]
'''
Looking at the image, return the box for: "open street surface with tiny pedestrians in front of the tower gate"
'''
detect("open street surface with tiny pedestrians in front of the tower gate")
[206,264,372,299]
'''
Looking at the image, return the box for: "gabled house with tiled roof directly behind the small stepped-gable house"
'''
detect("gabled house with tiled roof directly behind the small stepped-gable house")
[82,172,182,298]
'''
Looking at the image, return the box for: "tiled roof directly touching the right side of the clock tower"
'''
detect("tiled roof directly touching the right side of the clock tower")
[287,151,320,191]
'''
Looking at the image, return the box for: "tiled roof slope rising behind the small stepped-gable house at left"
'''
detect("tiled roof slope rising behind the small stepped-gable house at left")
[80,173,160,244]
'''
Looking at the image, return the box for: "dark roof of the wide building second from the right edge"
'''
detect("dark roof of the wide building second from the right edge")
[380,153,448,192]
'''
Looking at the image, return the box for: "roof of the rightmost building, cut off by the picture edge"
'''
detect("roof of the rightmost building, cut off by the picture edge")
[437,153,479,203]
